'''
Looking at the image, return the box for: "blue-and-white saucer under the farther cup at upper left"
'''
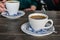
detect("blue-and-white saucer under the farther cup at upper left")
[1,11,25,19]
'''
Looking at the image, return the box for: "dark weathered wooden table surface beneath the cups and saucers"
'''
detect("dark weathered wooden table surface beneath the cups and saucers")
[0,11,60,40]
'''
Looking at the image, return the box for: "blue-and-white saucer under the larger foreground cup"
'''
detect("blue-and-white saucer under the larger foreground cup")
[21,22,55,36]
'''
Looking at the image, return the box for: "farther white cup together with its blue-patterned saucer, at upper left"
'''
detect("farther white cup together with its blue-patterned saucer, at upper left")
[1,1,25,19]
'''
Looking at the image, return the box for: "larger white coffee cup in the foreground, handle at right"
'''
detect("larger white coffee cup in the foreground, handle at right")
[28,13,53,31]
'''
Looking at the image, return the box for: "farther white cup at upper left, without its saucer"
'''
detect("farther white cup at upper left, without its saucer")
[5,1,20,15]
